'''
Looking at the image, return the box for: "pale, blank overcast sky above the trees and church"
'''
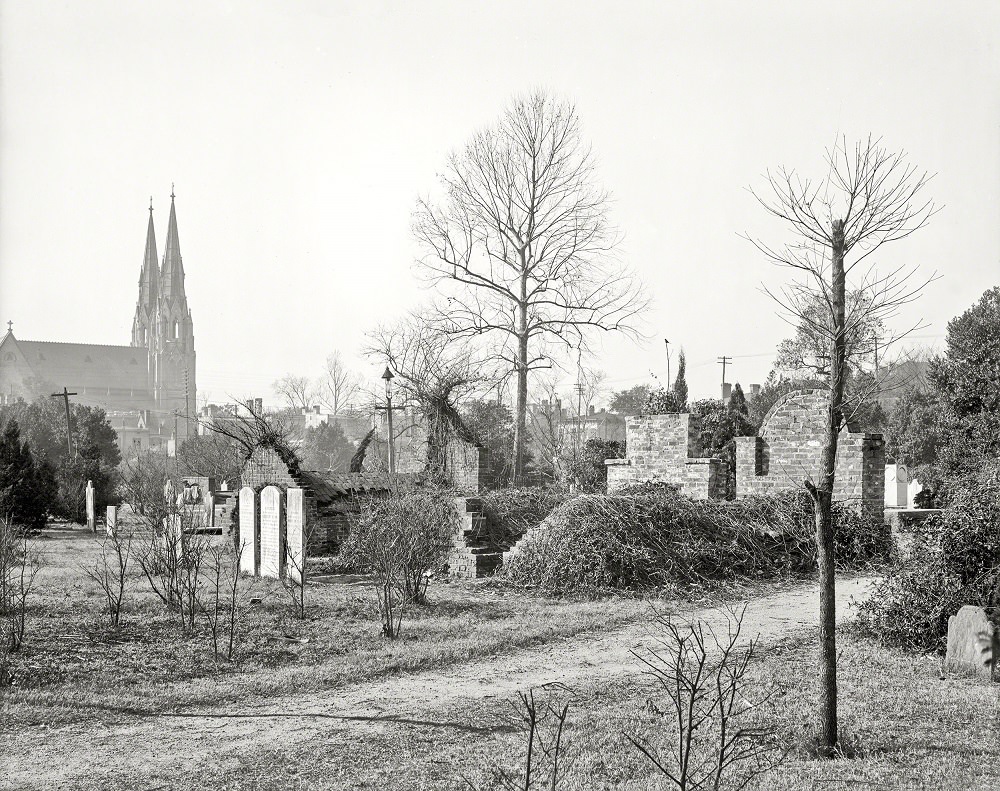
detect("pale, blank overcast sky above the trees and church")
[0,0,1000,408]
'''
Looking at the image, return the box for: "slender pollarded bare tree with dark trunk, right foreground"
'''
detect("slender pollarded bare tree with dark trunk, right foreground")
[750,136,935,754]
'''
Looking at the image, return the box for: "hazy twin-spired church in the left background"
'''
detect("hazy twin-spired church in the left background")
[0,190,198,453]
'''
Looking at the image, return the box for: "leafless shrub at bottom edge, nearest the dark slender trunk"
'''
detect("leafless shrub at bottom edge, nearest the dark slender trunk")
[625,607,785,791]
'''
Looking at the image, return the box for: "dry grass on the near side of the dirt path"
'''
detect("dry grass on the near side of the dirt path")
[162,635,1000,791]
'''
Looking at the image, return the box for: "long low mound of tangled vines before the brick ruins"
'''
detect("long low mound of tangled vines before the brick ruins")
[502,484,887,593]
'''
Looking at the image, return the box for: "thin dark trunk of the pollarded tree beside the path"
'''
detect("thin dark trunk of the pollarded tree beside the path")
[809,220,847,755]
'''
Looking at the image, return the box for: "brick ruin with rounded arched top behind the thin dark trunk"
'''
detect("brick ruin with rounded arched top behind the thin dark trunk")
[736,390,885,515]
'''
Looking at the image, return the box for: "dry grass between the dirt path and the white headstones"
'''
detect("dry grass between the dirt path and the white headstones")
[0,527,643,727]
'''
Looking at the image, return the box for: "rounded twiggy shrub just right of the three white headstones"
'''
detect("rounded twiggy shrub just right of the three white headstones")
[340,488,458,637]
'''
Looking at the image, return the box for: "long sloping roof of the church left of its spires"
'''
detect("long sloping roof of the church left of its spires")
[0,333,149,395]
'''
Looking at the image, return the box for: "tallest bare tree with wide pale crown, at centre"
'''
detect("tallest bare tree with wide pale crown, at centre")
[413,92,648,482]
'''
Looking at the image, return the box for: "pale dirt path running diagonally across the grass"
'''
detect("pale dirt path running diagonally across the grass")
[0,579,869,789]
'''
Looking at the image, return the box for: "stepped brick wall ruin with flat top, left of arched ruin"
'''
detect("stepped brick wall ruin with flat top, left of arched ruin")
[605,413,726,500]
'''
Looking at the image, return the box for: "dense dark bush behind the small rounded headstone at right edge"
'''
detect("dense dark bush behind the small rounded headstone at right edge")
[858,463,1000,651]
